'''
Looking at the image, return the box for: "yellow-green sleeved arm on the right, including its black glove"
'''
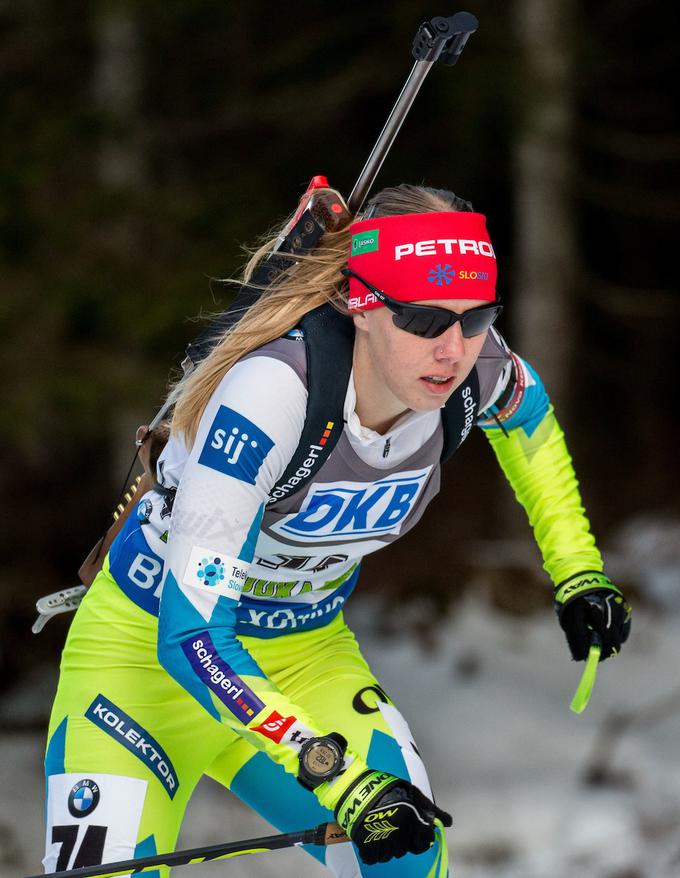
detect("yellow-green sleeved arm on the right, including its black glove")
[479,335,631,661]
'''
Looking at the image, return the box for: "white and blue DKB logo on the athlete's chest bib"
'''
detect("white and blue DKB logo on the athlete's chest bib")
[272,466,432,541]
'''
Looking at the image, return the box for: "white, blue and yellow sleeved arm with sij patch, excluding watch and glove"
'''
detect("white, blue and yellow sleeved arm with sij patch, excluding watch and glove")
[158,357,366,806]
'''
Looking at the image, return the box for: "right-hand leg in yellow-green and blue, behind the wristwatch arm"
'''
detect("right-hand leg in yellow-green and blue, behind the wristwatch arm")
[208,617,446,878]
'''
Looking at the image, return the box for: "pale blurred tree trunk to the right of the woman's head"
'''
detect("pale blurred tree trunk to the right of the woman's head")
[512,0,577,415]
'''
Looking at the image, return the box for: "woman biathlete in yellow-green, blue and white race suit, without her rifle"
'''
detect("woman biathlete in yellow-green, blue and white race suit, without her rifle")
[44,185,630,878]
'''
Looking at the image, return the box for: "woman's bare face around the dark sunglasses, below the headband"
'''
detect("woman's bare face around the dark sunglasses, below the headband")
[354,299,488,432]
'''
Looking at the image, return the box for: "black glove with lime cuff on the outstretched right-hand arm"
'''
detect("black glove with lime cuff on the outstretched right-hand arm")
[555,571,632,662]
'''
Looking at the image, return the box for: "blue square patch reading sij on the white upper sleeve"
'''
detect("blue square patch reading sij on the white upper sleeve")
[198,405,274,485]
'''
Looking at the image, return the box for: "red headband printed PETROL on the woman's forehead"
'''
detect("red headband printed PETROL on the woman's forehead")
[347,211,496,311]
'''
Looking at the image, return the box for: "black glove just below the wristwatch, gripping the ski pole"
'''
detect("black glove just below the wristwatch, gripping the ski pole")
[335,771,452,865]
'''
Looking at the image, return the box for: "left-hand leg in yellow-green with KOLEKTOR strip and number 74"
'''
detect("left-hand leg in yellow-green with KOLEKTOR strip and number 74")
[44,574,234,872]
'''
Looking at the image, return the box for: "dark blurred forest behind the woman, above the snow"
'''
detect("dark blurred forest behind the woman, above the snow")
[0,0,680,872]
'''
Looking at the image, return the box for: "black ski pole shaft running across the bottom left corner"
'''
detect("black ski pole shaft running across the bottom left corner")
[30,823,349,878]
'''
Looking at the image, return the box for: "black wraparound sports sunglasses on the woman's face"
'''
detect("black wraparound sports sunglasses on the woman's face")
[341,268,503,338]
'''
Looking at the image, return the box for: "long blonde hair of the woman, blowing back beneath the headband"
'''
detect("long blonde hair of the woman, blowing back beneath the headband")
[169,183,472,447]
